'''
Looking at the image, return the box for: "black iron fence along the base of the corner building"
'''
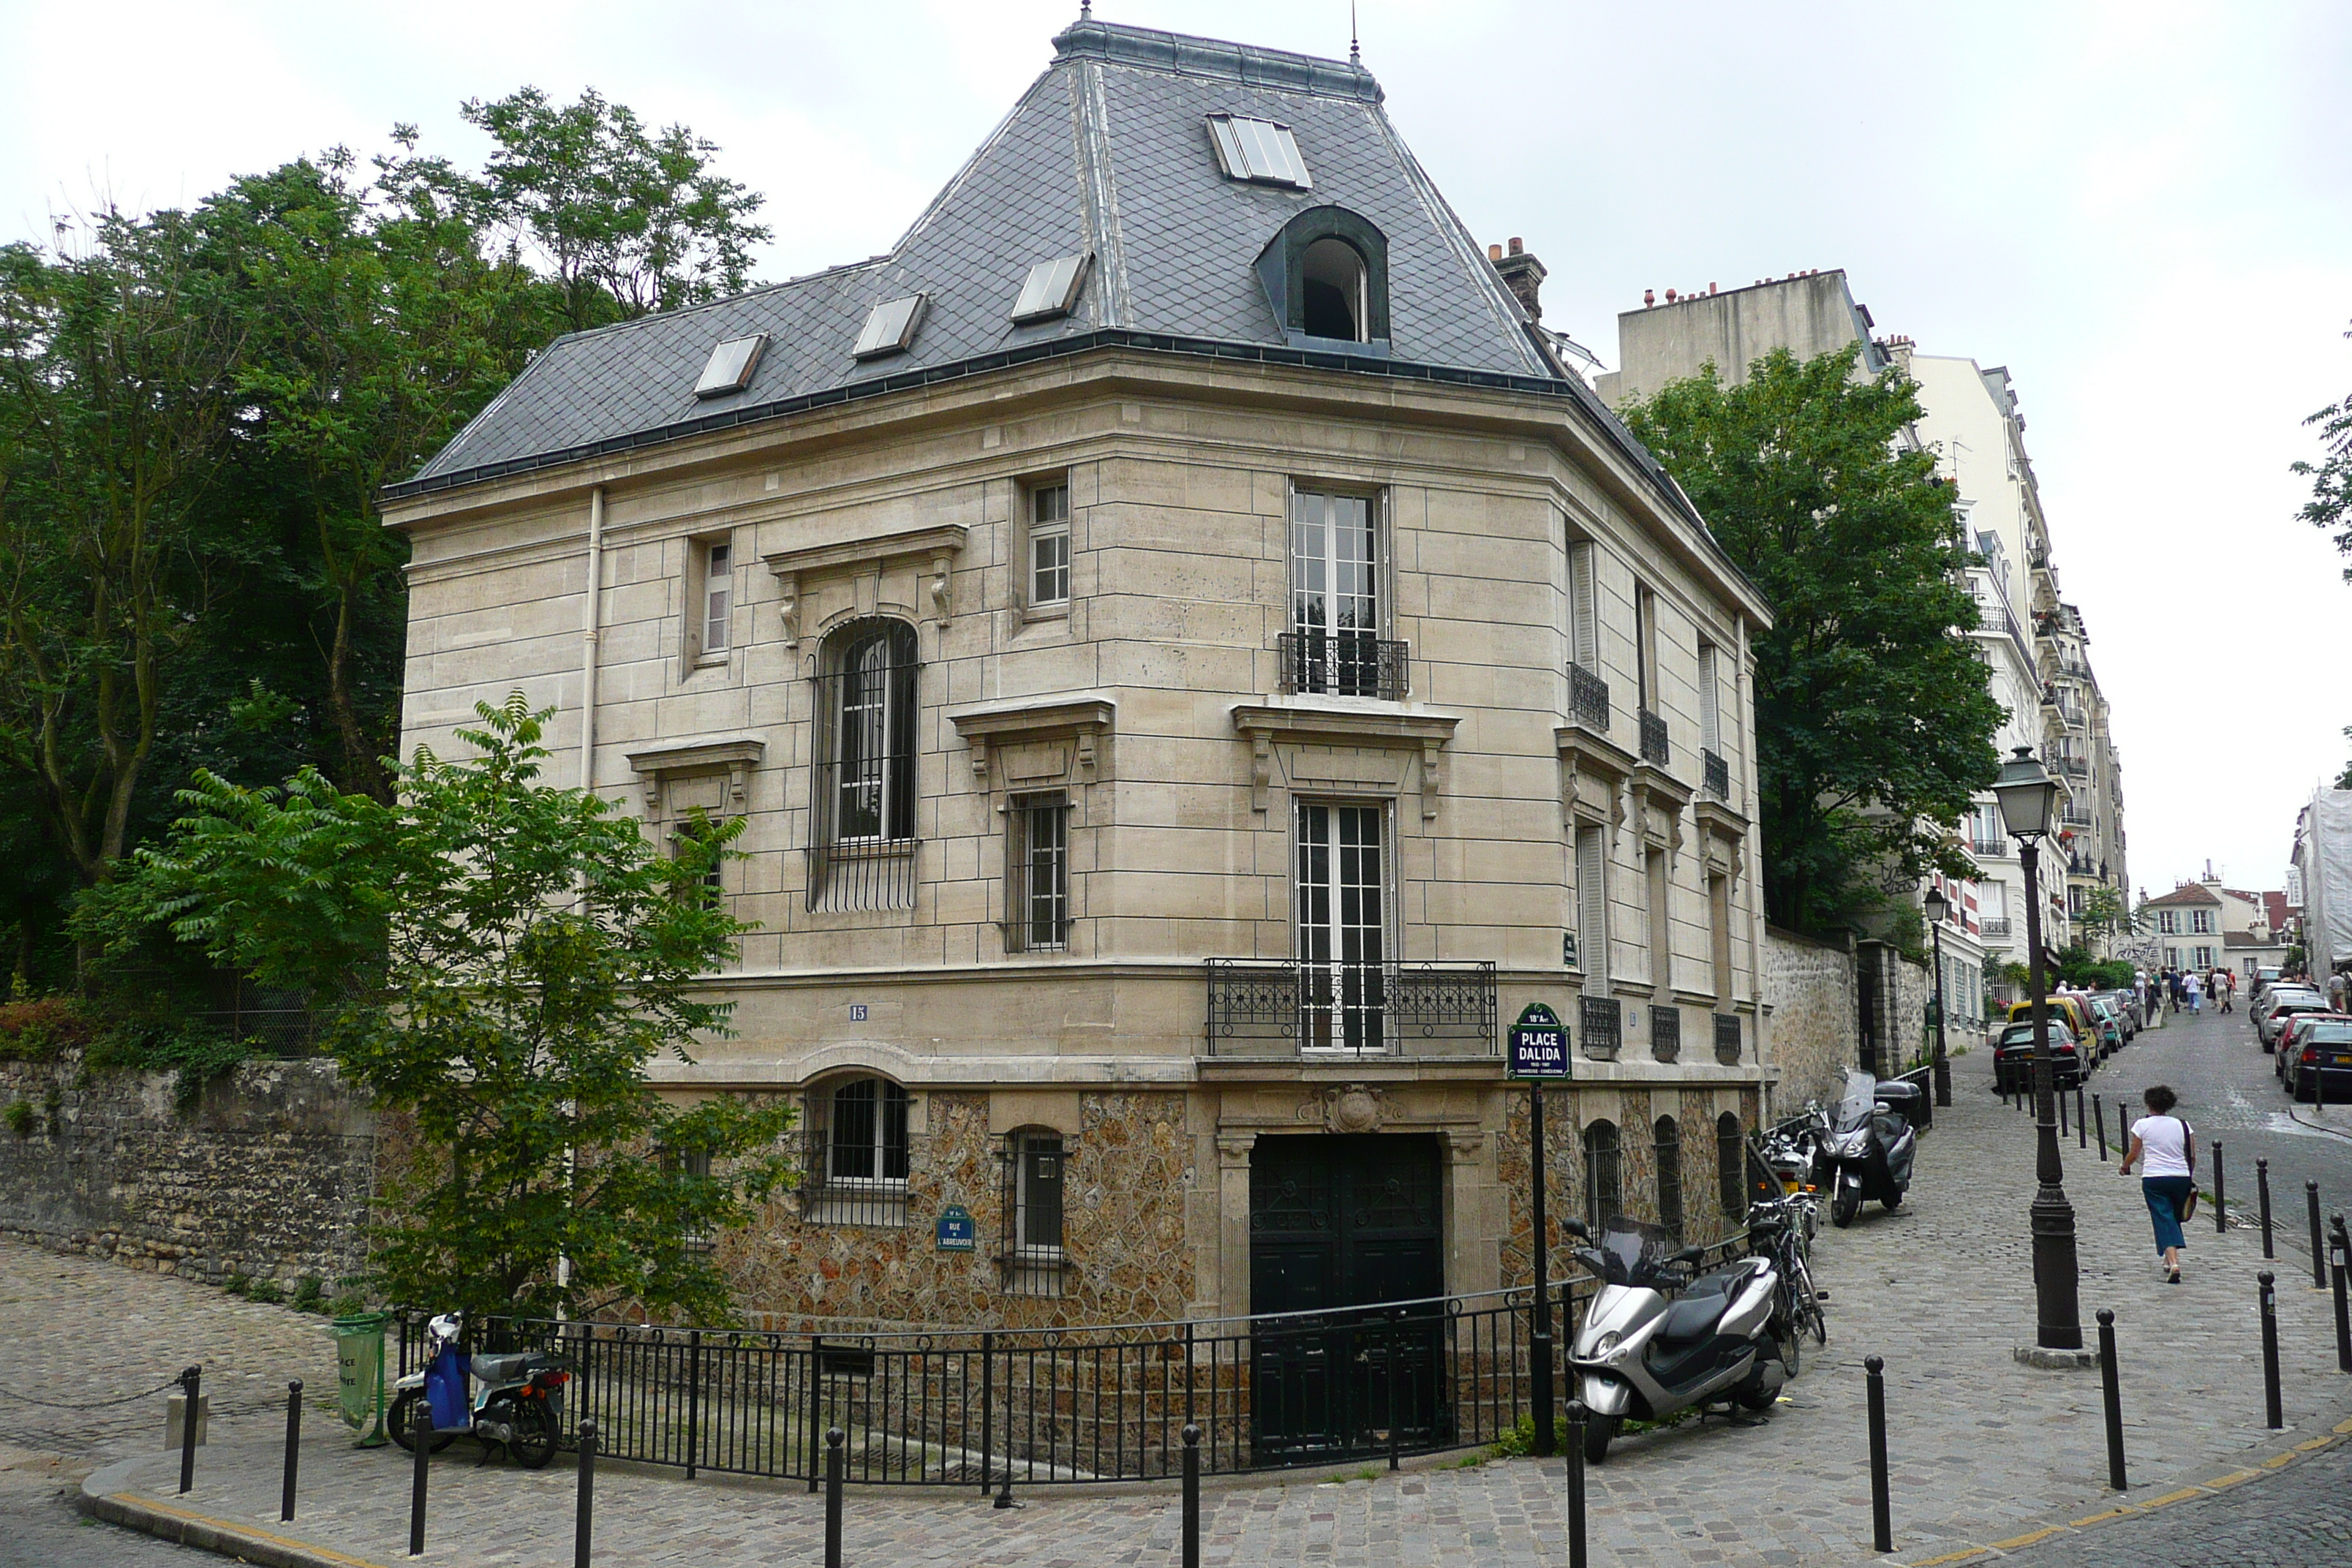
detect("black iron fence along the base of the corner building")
[398,1259,1745,1490]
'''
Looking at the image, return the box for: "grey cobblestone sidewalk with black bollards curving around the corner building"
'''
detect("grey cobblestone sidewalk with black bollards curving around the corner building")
[13,1058,2352,1568]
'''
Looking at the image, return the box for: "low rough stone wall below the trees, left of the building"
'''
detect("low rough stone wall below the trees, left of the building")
[0,1053,379,1295]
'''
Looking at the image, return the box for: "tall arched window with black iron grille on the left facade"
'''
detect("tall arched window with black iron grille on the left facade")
[809,621,919,910]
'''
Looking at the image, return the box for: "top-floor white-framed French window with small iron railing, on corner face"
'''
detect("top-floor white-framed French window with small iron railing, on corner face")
[1284,489,1373,696]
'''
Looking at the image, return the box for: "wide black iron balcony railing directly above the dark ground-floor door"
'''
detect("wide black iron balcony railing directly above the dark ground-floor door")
[1207,959,1499,1060]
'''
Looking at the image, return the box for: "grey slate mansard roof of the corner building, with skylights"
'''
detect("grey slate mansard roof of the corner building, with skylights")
[385,21,1637,498]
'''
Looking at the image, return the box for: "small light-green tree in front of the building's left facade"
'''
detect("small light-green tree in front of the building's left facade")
[101,693,791,1321]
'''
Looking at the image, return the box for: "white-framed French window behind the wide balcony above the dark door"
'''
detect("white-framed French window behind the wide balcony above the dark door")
[1294,802,1387,1051]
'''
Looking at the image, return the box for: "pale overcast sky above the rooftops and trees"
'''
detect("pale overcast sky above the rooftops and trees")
[0,0,2352,893]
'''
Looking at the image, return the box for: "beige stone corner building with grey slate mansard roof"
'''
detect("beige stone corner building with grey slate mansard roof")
[388,21,1771,1326]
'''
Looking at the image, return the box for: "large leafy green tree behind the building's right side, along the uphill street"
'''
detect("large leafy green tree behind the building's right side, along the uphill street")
[1625,348,2002,931]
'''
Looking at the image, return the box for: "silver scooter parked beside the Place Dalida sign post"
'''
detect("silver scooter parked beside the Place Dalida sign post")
[1559,1218,1795,1465]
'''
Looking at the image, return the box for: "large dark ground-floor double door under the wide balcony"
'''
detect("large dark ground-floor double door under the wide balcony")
[1249,1133,1447,1462]
